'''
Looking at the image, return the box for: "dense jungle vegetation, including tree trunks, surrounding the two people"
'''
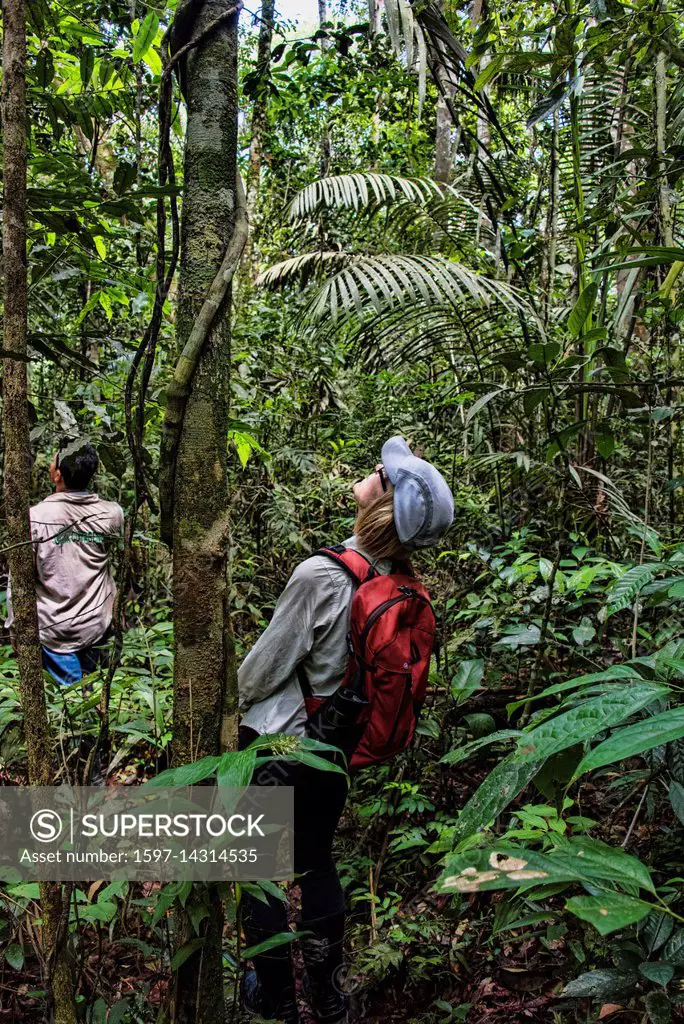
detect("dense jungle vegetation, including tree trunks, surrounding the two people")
[0,0,684,1024]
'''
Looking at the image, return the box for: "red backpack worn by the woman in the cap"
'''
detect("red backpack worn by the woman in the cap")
[297,545,435,771]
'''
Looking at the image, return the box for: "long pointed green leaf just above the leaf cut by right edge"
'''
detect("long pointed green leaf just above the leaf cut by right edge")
[514,683,670,761]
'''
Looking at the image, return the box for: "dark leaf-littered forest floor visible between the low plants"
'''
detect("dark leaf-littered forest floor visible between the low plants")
[0,690,684,1024]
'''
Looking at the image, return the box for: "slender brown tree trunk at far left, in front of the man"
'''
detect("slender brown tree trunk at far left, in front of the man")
[2,0,76,1024]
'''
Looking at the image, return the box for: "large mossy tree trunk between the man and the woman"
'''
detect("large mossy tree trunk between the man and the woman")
[173,0,238,1024]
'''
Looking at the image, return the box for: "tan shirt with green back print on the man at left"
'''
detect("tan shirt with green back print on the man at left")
[5,492,124,653]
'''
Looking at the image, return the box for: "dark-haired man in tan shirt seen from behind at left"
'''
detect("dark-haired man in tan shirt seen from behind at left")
[5,437,124,685]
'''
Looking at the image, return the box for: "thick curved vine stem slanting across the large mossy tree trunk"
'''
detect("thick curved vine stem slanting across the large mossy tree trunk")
[159,174,249,547]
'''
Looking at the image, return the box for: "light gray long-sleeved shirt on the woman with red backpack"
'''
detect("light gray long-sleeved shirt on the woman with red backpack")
[238,537,391,736]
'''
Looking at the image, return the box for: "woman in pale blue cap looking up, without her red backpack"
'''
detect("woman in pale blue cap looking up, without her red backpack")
[239,436,454,1024]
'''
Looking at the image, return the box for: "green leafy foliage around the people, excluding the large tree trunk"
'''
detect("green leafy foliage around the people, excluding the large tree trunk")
[0,0,684,1024]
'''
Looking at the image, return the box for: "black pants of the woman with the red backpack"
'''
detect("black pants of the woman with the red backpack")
[240,726,348,934]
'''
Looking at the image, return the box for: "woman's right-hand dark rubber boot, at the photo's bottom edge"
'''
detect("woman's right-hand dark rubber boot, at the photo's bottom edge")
[298,913,348,1024]
